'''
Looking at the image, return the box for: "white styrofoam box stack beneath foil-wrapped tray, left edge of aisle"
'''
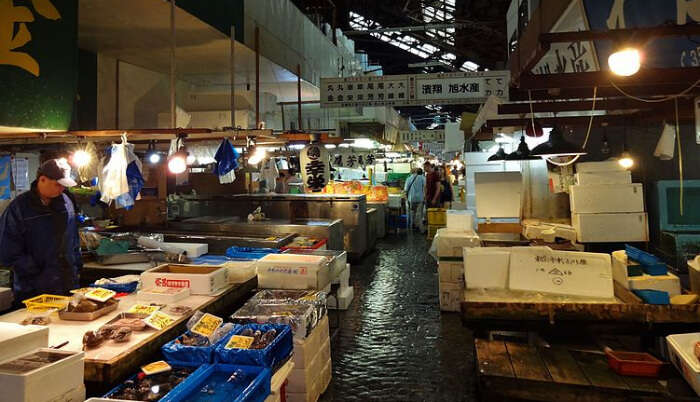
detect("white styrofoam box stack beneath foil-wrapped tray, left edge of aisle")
[286,315,331,402]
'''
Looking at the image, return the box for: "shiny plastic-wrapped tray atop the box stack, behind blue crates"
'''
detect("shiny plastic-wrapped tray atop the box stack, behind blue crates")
[231,301,319,339]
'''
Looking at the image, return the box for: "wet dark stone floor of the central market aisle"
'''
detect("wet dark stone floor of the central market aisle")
[320,233,477,402]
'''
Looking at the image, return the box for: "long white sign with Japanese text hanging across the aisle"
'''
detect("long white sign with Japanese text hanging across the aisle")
[321,71,510,107]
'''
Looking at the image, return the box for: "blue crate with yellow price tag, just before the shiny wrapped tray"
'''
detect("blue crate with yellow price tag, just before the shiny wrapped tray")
[214,324,294,370]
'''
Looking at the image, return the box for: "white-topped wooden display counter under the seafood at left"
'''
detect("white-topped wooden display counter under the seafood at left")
[0,278,257,389]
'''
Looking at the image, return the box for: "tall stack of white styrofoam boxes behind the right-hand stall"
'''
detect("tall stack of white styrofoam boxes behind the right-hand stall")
[569,161,649,243]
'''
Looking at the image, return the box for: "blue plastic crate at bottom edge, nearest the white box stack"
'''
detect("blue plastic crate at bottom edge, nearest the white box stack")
[161,364,271,402]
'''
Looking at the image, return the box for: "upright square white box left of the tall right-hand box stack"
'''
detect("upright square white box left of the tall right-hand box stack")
[474,172,523,218]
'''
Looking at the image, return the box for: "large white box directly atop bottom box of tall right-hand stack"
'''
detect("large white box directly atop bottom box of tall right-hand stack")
[569,183,644,214]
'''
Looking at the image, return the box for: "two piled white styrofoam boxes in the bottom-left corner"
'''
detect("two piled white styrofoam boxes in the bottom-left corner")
[0,323,85,402]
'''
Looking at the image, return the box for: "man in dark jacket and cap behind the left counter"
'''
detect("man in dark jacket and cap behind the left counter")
[0,159,83,306]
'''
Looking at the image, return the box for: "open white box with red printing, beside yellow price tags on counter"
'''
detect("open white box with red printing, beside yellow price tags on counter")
[141,264,228,295]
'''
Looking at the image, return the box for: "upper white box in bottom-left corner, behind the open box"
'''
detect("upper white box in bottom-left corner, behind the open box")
[0,322,49,361]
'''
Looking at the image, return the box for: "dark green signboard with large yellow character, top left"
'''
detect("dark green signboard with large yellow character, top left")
[0,0,78,130]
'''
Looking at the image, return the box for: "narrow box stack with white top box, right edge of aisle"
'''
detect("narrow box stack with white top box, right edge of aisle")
[435,210,481,311]
